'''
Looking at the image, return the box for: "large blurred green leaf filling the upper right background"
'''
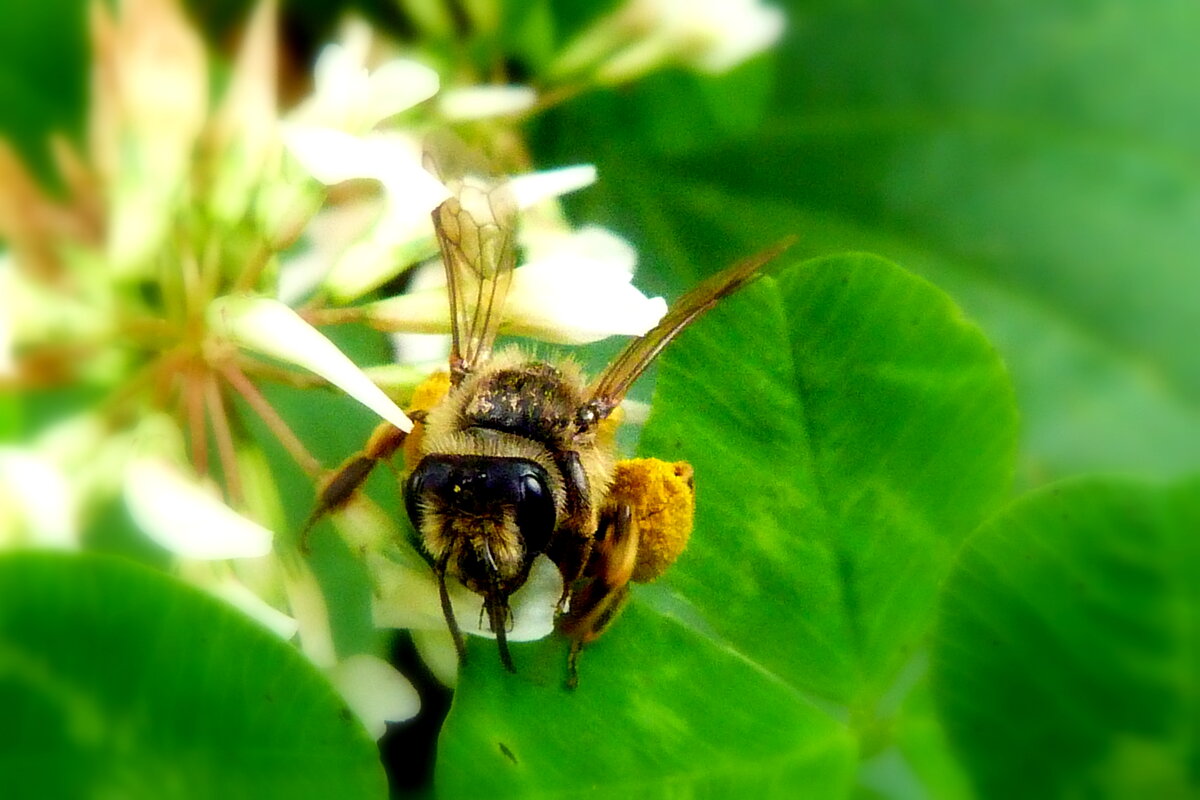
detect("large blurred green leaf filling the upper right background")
[539,0,1200,483]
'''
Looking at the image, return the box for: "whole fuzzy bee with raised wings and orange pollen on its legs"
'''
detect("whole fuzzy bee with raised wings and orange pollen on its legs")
[310,172,791,687]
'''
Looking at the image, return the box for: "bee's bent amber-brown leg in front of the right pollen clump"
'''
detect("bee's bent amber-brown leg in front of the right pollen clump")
[559,504,638,688]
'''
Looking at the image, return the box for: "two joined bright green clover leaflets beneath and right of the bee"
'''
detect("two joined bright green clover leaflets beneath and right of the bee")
[438,255,1015,796]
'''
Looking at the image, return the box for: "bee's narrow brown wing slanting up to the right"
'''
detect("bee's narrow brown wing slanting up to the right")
[587,236,796,419]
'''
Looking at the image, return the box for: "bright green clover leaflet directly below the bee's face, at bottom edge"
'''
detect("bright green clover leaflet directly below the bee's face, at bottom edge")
[434,603,853,798]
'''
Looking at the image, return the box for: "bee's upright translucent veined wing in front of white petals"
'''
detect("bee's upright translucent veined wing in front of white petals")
[433,185,516,383]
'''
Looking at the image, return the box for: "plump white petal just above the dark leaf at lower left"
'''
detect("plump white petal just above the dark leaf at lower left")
[125,457,272,560]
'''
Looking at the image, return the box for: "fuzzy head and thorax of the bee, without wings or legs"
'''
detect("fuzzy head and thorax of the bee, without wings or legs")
[404,348,614,671]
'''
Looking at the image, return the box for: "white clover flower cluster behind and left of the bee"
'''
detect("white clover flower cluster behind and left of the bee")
[0,0,779,734]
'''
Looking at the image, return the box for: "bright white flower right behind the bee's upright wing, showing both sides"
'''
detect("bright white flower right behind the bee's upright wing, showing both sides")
[366,227,667,344]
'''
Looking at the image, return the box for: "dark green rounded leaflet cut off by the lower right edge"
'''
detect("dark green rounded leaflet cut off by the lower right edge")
[932,479,1200,798]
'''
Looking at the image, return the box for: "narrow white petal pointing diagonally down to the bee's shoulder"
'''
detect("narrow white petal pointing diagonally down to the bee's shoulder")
[209,295,413,432]
